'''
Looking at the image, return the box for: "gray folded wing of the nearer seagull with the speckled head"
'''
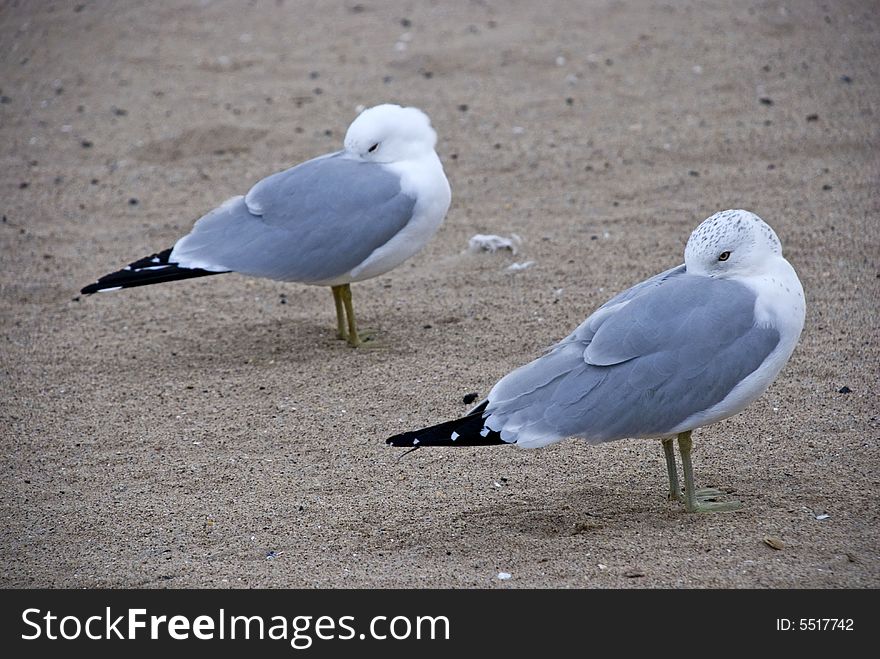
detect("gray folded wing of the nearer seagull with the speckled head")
[486,271,779,446]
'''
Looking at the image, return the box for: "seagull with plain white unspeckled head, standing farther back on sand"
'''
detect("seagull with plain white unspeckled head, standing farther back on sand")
[81,104,451,346]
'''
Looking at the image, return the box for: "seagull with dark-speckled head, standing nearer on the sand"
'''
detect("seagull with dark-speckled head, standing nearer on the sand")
[386,210,805,512]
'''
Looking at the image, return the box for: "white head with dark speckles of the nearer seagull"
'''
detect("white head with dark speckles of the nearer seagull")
[684,210,782,277]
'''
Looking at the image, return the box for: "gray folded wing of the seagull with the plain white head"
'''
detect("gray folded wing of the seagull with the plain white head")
[171,152,416,283]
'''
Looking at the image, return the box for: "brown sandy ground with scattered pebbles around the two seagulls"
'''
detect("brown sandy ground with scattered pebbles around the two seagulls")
[0,0,880,588]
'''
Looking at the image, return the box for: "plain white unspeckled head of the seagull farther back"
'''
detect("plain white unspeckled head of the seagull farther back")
[345,103,437,163]
